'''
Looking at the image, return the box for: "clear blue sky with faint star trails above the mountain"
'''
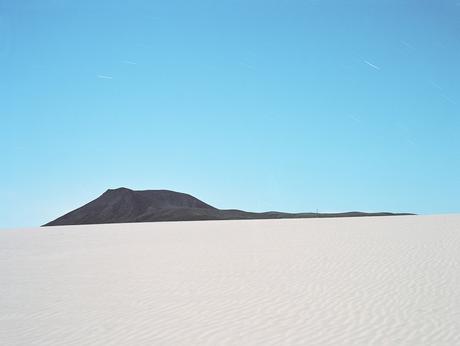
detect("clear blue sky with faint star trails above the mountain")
[0,0,460,228]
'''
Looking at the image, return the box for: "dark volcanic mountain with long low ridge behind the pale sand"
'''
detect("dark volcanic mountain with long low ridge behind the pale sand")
[44,188,407,226]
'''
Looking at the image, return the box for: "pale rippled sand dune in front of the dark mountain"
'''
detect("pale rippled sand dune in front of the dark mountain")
[0,215,460,345]
